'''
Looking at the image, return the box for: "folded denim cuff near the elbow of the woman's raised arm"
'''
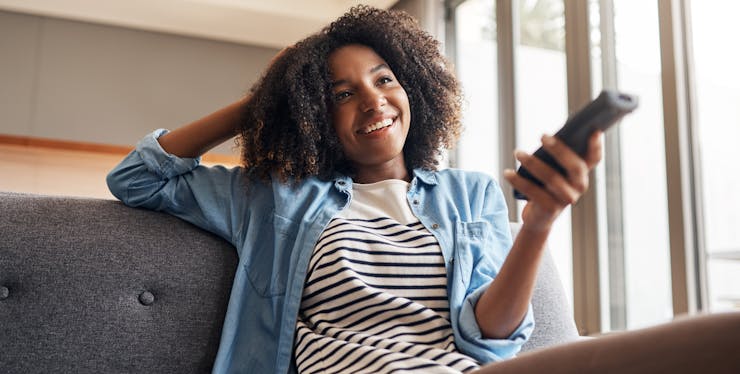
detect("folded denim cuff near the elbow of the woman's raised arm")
[136,129,200,179]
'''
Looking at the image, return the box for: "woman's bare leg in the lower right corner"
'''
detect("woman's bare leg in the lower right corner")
[478,312,740,374]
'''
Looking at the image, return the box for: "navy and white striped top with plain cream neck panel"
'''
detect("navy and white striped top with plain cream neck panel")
[295,180,478,373]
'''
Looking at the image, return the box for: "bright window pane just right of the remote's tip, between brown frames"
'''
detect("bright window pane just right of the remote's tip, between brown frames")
[606,0,673,329]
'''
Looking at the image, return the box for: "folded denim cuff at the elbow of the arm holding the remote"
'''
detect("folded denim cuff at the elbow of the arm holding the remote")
[460,284,534,361]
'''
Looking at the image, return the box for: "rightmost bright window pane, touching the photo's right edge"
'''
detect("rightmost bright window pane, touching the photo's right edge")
[691,1,740,311]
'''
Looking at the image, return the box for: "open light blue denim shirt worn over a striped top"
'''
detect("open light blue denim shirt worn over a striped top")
[107,129,534,373]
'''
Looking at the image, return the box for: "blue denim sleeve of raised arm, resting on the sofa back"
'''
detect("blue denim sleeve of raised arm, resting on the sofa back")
[106,129,244,243]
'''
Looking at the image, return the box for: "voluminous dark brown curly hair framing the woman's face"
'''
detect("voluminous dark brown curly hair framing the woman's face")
[238,6,462,182]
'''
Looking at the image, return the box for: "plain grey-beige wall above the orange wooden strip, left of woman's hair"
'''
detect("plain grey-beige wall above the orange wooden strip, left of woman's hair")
[0,12,277,153]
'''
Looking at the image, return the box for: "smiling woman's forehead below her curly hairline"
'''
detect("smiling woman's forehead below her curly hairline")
[328,44,388,78]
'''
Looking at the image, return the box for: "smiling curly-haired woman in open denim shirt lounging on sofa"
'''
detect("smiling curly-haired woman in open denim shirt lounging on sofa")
[108,6,736,373]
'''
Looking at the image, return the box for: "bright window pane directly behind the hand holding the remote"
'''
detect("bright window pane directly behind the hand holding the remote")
[510,0,573,305]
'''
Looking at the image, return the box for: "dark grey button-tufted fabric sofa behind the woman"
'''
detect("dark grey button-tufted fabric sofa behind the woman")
[0,192,578,373]
